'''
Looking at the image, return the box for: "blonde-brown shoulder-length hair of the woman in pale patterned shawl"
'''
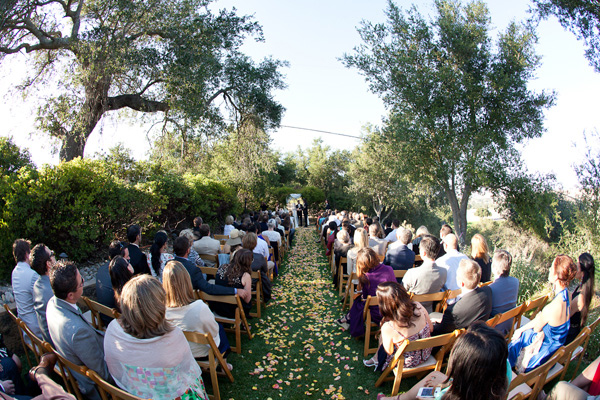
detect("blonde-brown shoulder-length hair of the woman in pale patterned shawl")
[119,274,173,339]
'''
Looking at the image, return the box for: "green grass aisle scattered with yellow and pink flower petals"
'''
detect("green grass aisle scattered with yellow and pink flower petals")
[220,227,412,400]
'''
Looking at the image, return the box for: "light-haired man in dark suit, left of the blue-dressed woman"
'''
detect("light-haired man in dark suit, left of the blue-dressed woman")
[432,259,492,336]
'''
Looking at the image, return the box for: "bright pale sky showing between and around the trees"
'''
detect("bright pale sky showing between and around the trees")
[0,0,600,188]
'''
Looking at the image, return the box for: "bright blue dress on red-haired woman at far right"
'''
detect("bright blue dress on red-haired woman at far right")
[508,289,571,372]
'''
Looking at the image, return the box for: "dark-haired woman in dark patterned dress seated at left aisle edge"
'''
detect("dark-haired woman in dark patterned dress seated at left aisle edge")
[211,249,253,318]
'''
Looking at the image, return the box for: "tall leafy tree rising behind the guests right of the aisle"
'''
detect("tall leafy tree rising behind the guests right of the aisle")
[343,0,553,240]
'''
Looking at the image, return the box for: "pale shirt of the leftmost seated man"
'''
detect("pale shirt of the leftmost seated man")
[11,261,42,340]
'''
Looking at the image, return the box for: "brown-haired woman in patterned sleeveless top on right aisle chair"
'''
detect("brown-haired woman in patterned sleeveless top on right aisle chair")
[364,282,433,371]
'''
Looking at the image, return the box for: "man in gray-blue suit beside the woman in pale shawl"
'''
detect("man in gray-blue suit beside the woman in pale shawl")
[46,261,112,400]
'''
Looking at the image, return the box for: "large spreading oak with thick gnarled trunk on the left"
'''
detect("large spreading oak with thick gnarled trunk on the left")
[0,0,285,160]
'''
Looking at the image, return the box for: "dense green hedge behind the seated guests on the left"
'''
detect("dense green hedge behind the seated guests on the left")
[0,148,240,278]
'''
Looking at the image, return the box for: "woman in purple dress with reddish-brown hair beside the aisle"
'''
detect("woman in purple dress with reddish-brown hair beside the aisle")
[336,248,396,337]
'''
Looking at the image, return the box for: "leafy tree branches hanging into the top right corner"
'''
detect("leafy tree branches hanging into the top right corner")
[533,0,600,72]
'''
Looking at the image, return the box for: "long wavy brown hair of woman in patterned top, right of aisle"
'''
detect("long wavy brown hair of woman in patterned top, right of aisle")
[377,282,421,328]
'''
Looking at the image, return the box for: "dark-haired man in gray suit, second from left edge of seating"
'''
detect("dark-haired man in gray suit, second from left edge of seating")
[31,243,56,343]
